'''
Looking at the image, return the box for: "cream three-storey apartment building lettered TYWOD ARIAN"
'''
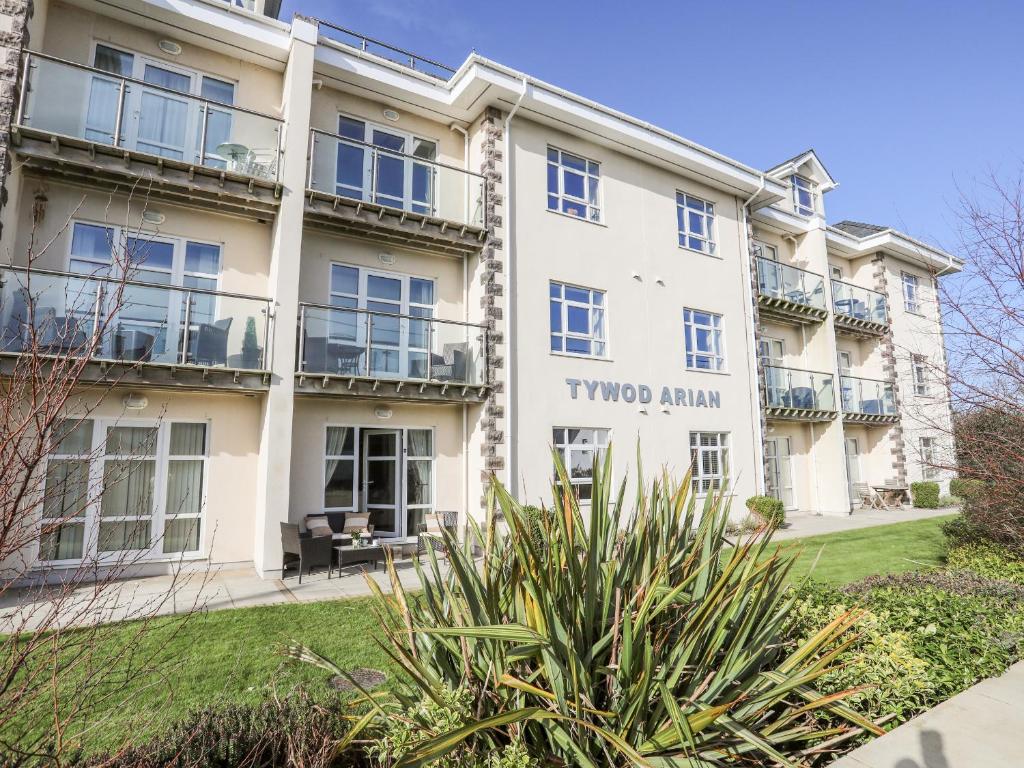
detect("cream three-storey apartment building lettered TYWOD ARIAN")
[0,0,961,574]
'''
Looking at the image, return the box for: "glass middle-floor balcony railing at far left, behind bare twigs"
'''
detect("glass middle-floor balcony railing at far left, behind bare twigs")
[0,267,270,371]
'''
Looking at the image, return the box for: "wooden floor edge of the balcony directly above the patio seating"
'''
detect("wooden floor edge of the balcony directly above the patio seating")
[295,373,488,403]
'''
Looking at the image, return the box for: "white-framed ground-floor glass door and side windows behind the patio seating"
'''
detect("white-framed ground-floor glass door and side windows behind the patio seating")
[324,426,434,537]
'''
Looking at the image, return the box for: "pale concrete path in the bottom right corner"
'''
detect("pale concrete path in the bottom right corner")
[830,662,1024,768]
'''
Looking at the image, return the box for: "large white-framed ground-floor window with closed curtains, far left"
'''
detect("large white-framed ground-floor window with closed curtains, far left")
[39,419,208,562]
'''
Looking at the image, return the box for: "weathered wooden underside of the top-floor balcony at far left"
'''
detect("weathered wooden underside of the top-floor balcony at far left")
[11,126,281,219]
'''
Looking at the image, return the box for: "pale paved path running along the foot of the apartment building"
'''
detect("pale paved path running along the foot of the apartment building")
[0,507,956,630]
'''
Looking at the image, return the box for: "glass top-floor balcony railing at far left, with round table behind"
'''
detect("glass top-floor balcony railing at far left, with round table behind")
[17,53,282,181]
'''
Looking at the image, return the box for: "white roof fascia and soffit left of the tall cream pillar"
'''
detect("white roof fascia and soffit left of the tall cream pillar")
[97,0,291,64]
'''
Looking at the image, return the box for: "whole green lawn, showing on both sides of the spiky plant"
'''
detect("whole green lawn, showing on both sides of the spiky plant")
[4,517,948,752]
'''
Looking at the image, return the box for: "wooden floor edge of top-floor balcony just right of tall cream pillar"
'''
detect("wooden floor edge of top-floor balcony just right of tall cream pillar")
[305,189,486,256]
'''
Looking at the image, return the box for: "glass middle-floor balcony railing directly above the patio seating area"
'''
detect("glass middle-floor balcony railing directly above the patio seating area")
[298,303,487,386]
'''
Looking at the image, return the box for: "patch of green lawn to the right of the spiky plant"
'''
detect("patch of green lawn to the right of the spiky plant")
[779,515,952,584]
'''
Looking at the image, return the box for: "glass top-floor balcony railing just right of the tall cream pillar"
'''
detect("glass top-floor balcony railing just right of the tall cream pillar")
[308,128,484,227]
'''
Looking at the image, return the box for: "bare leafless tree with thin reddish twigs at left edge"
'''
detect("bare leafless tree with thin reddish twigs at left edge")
[0,185,206,765]
